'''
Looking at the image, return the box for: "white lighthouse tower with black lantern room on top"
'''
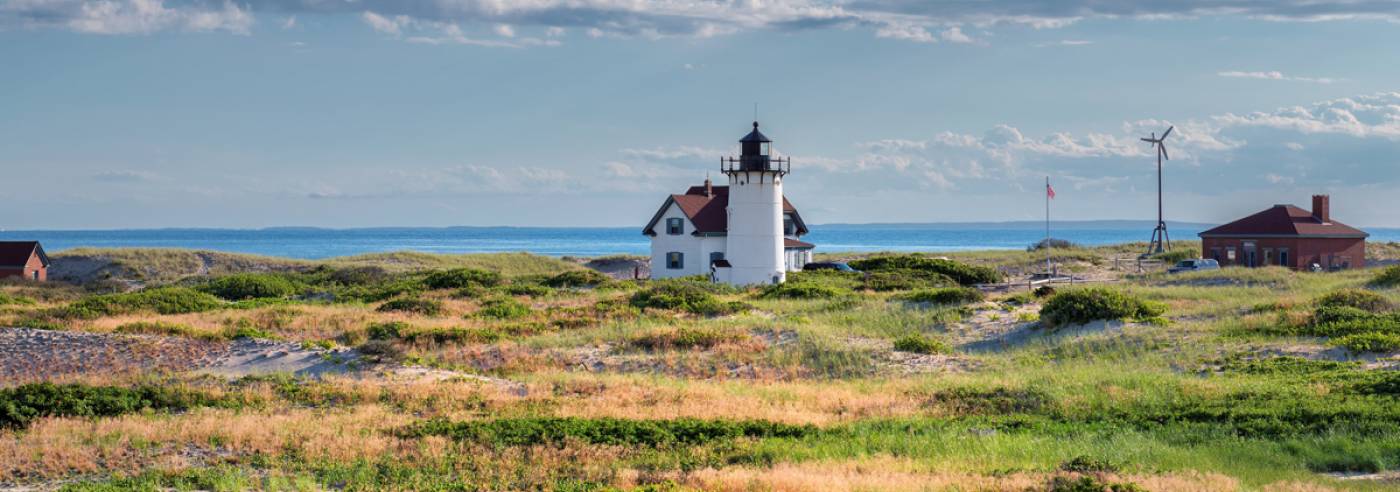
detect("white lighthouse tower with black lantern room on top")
[717,122,791,285]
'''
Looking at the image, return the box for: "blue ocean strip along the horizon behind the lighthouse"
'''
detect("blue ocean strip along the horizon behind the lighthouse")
[0,221,1400,259]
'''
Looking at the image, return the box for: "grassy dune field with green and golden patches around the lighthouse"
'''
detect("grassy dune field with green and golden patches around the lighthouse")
[0,245,1400,491]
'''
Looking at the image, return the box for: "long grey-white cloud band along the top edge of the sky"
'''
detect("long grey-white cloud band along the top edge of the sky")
[13,0,1400,46]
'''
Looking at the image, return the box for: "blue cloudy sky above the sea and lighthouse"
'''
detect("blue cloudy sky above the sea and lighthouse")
[0,0,1400,230]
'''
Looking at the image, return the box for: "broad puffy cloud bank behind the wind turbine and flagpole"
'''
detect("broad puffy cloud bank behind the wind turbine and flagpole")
[792,93,1400,204]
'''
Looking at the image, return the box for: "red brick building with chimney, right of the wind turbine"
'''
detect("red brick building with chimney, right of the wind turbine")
[1200,195,1371,271]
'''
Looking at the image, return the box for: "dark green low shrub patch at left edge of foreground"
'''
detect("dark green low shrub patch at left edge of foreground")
[0,383,217,429]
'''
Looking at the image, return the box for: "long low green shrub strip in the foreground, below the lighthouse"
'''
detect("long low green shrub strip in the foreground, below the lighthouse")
[402,416,819,447]
